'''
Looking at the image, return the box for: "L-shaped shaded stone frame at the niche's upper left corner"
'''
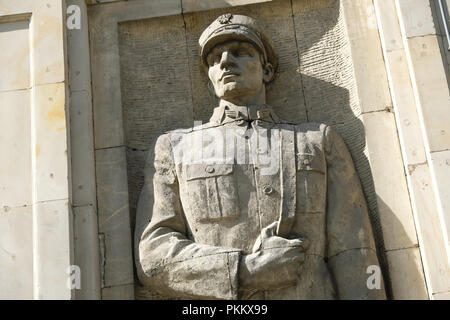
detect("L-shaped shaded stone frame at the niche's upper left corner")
[88,0,181,149]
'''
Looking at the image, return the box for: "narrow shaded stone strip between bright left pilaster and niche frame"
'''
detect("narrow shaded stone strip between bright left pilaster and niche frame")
[67,0,101,300]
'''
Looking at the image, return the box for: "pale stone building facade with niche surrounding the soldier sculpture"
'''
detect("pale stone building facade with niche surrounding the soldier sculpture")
[0,0,450,299]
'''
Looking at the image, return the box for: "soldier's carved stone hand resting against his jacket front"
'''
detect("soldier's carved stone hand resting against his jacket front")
[239,222,308,290]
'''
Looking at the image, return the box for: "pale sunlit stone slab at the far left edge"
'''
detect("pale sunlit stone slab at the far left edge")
[0,6,33,299]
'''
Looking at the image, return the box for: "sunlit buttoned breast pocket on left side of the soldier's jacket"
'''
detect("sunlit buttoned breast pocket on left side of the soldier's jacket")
[186,164,239,221]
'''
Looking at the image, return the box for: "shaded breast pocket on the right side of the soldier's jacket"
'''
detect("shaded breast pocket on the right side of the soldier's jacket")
[296,153,327,213]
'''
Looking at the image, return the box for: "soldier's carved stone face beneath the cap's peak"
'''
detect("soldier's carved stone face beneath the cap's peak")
[207,40,265,100]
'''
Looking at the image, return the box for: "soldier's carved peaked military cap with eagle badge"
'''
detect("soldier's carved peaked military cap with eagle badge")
[198,13,278,70]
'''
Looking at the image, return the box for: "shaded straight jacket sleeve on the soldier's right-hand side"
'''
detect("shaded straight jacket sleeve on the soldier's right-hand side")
[325,127,386,299]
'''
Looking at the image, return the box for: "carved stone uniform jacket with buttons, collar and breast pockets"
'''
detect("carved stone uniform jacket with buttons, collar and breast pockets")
[136,106,385,299]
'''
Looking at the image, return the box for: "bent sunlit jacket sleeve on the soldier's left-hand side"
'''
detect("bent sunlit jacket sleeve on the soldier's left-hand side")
[138,134,240,299]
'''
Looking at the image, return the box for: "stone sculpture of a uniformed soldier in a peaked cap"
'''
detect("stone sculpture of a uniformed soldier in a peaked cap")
[136,14,385,299]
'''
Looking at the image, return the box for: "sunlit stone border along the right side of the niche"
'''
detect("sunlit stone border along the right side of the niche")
[341,0,427,298]
